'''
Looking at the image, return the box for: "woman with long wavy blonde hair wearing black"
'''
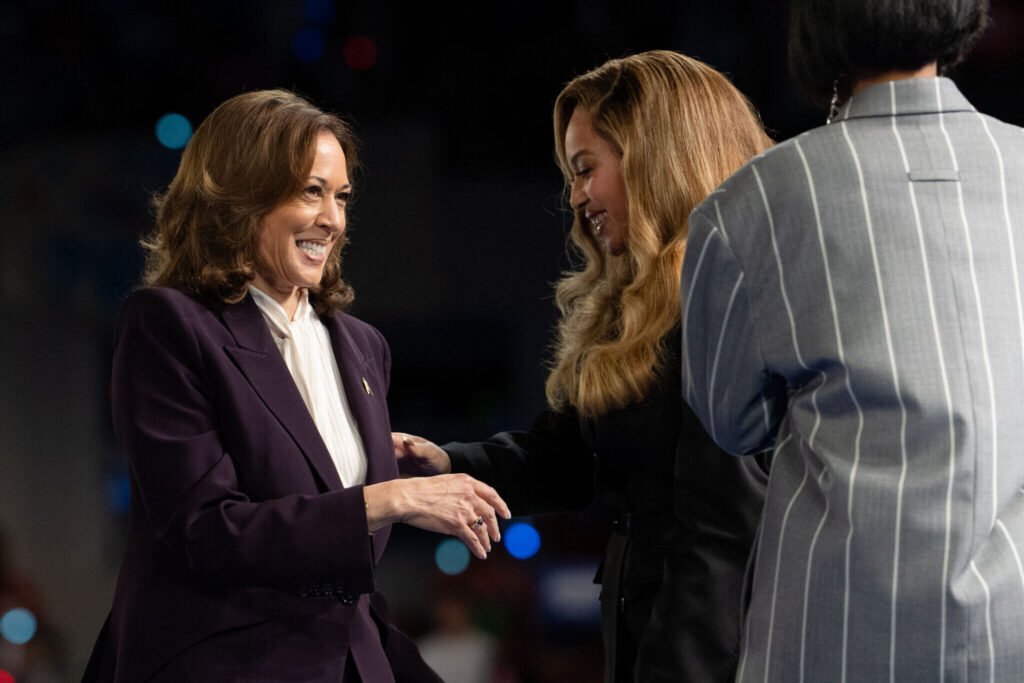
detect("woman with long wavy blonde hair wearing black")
[394,51,770,683]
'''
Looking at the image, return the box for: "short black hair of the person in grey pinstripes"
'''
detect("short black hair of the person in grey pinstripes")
[790,0,988,103]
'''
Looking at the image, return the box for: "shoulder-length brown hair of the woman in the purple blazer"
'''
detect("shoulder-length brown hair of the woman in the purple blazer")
[142,90,357,315]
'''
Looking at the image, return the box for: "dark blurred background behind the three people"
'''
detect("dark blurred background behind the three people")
[0,0,1024,681]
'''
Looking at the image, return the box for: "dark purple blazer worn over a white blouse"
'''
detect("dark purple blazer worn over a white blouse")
[86,289,439,683]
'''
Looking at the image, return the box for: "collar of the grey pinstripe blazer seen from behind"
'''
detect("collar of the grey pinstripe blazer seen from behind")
[833,77,976,123]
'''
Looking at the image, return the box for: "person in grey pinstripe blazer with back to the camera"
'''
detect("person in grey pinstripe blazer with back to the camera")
[682,0,1024,683]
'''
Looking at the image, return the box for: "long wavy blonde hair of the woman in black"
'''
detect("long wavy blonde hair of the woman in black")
[546,50,772,417]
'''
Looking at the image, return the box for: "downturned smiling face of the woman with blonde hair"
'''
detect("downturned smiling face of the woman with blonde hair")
[565,106,629,255]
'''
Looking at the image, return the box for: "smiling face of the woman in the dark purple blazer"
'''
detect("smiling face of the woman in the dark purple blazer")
[253,132,351,317]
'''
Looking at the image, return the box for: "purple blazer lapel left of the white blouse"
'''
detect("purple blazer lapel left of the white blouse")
[222,295,342,490]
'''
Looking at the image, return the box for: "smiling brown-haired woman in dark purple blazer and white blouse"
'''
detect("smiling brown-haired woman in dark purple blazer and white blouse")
[85,91,508,683]
